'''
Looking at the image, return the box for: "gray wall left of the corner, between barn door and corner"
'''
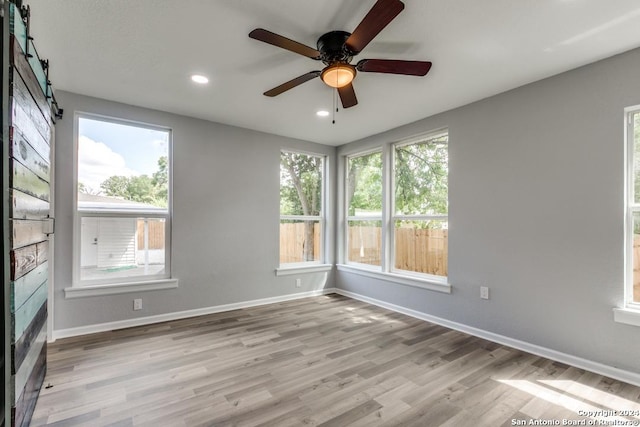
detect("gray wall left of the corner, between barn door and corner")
[54,91,336,330]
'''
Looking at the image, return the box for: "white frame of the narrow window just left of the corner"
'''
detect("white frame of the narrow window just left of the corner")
[276,148,332,276]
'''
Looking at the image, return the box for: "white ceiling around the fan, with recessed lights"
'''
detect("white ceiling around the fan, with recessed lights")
[26,0,640,145]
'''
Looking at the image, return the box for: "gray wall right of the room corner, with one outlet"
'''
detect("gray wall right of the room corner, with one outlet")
[336,46,640,372]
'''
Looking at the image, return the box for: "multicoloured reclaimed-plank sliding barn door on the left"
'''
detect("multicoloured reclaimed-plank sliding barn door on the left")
[2,3,59,426]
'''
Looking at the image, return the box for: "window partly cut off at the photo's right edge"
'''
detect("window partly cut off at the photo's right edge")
[625,108,640,310]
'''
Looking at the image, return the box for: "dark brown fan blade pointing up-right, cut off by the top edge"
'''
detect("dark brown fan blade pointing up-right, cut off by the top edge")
[345,0,404,54]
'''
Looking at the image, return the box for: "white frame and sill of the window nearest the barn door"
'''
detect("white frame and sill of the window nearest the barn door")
[65,112,178,298]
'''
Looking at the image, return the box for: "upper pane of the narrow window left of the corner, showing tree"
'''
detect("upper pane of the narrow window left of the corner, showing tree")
[280,152,322,216]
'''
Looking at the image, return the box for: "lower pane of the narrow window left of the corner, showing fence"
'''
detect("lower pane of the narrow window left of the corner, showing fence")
[280,220,322,264]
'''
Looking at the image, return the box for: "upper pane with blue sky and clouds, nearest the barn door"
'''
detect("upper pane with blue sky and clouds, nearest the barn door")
[78,117,169,211]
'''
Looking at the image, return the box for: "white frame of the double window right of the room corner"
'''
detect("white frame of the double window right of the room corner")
[338,128,451,293]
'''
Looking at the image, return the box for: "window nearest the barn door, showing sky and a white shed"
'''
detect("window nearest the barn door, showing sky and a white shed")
[74,115,171,286]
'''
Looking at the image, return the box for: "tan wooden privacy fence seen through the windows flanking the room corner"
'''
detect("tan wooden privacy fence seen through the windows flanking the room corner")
[280,223,448,276]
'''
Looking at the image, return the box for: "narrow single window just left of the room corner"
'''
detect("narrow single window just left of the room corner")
[280,151,325,267]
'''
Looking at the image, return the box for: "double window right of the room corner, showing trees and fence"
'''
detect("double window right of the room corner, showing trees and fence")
[344,131,448,283]
